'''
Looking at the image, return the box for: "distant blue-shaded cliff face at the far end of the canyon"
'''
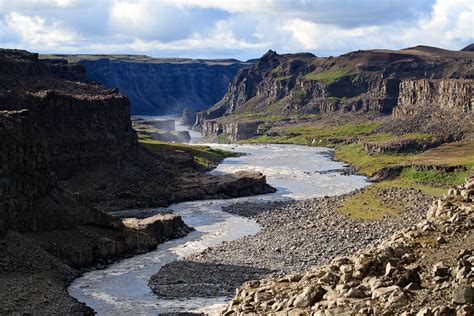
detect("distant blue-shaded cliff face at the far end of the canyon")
[75,58,248,115]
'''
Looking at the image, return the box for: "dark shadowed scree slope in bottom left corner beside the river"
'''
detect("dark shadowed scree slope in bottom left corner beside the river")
[0,231,94,315]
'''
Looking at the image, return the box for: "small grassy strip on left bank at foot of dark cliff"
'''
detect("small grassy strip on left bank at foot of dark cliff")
[140,139,236,169]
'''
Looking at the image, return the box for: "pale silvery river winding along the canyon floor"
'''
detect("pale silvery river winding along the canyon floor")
[68,118,367,315]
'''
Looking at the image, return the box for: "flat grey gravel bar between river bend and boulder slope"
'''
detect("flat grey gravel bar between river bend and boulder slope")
[150,189,432,297]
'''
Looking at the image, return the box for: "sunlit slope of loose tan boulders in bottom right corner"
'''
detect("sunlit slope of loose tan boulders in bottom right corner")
[222,174,474,315]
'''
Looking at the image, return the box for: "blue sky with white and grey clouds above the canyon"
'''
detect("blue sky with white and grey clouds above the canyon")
[0,0,474,60]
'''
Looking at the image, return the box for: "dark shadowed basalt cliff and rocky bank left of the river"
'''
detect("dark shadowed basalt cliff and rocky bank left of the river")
[0,49,272,314]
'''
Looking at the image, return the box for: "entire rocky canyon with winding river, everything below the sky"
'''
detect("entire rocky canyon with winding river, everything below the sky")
[0,42,474,315]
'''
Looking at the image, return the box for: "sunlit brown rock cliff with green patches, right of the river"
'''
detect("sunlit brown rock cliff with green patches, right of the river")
[196,46,474,141]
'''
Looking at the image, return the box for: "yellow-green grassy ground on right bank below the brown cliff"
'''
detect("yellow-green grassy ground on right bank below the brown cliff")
[241,122,474,219]
